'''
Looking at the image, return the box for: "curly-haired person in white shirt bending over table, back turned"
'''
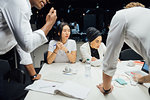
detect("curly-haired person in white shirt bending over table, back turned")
[97,2,150,94]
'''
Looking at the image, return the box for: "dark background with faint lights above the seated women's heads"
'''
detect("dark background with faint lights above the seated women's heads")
[31,0,150,49]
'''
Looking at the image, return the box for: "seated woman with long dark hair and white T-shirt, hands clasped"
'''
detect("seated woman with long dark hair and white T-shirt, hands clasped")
[47,22,77,64]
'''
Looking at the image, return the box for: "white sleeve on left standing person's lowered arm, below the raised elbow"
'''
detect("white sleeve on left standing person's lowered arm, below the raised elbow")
[16,45,33,65]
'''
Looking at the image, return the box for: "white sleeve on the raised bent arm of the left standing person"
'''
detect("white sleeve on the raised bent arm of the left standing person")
[1,0,47,52]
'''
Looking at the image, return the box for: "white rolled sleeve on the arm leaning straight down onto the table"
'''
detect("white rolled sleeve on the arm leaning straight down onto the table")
[103,12,126,76]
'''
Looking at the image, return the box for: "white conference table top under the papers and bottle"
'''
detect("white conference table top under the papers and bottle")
[25,61,150,100]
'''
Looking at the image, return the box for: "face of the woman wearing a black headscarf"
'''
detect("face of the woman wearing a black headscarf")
[90,36,102,49]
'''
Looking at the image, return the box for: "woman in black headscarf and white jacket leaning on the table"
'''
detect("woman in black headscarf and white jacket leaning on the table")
[80,27,106,66]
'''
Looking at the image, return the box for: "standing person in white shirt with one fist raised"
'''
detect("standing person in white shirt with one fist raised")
[0,0,57,81]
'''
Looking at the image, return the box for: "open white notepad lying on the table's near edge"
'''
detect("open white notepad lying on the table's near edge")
[25,80,90,99]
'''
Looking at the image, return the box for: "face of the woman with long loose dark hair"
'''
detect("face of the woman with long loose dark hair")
[61,25,70,40]
